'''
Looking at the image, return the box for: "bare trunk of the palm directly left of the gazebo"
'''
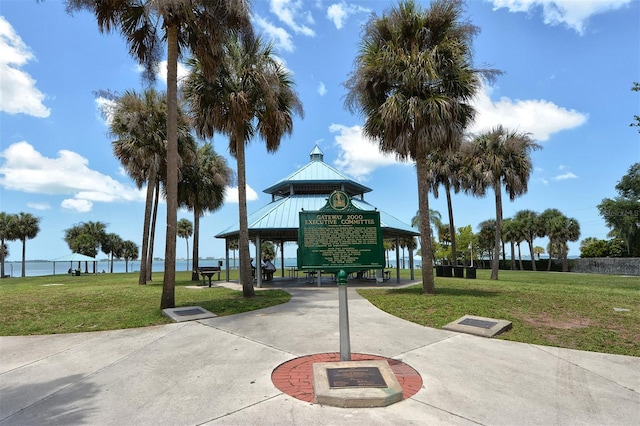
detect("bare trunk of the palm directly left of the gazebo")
[232,132,255,297]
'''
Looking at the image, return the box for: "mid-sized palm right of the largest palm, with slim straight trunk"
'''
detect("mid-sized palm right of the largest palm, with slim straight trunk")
[464,126,541,280]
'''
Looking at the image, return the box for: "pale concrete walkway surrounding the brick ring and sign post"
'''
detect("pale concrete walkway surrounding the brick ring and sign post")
[0,284,640,426]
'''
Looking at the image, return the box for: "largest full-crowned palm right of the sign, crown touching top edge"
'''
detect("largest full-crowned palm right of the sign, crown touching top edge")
[345,0,490,294]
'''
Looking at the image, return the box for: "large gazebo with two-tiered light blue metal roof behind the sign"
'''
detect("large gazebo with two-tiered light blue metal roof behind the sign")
[215,145,420,287]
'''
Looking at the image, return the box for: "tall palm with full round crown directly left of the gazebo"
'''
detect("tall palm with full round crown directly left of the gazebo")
[184,37,303,297]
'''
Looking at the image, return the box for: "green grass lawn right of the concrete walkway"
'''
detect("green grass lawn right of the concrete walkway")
[358,270,640,356]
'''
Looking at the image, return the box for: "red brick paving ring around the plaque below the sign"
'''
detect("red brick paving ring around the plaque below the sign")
[271,352,422,402]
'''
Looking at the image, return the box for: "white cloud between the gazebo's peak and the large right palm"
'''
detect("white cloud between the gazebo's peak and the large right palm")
[329,124,410,180]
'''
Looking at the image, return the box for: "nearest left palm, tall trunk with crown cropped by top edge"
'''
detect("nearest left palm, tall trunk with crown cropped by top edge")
[67,0,252,309]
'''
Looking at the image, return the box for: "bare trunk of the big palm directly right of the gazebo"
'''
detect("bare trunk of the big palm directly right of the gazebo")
[416,156,436,294]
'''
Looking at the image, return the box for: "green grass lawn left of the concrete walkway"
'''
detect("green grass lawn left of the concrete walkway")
[0,272,291,336]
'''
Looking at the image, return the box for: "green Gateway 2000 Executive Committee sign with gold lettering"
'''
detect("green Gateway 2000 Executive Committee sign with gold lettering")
[298,191,384,272]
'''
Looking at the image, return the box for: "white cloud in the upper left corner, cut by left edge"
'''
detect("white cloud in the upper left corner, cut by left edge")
[0,16,51,118]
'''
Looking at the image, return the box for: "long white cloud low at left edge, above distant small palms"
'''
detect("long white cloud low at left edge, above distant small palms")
[0,141,144,211]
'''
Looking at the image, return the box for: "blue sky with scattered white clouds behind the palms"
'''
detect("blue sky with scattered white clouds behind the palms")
[0,0,640,261]
